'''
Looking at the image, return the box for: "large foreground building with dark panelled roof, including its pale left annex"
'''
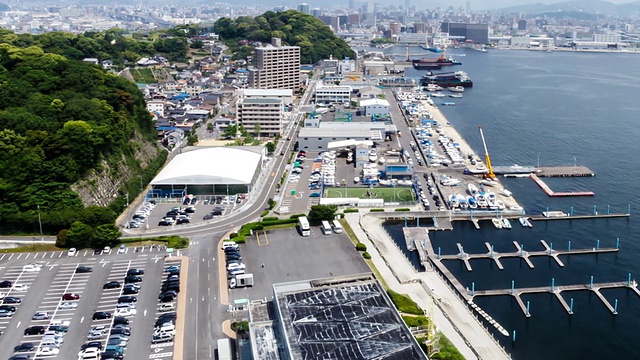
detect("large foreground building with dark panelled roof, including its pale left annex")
[249,274,428,360]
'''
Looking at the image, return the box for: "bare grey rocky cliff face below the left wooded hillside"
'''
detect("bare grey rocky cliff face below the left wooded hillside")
[71,132,160,206]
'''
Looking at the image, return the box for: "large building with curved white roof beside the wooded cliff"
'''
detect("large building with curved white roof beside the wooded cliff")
[150,146,266,198]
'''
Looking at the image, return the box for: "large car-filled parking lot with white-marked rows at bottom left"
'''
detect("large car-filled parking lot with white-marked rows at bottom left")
[0,248,180,359]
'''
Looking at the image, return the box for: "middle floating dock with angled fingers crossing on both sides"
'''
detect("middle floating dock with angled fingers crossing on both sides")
[436,240,619,271]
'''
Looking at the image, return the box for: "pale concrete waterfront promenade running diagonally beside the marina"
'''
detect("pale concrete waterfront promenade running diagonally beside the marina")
[345,213,510,360]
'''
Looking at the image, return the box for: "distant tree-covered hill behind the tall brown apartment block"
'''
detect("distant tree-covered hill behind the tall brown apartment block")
[214,10,355,64]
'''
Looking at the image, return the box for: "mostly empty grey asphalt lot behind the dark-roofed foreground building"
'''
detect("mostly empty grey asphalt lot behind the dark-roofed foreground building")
[228,226,371,303]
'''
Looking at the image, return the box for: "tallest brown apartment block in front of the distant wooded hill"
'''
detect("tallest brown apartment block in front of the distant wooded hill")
[249,38,300,91]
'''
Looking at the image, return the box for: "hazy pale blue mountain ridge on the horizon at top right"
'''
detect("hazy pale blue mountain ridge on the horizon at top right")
[500,0,640,16]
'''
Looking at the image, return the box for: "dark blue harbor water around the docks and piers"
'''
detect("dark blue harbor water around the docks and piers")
[380,47,640,360]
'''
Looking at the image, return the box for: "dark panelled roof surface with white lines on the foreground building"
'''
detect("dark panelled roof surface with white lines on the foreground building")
[284,282,424,360]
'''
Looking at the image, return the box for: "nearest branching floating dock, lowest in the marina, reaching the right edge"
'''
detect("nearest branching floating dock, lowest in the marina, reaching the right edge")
[466,280,640,317]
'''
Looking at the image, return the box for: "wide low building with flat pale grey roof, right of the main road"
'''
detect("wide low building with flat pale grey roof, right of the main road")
[298,121,397,151]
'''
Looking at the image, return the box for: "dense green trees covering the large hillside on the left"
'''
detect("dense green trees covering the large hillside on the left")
[0,43,155,239]
